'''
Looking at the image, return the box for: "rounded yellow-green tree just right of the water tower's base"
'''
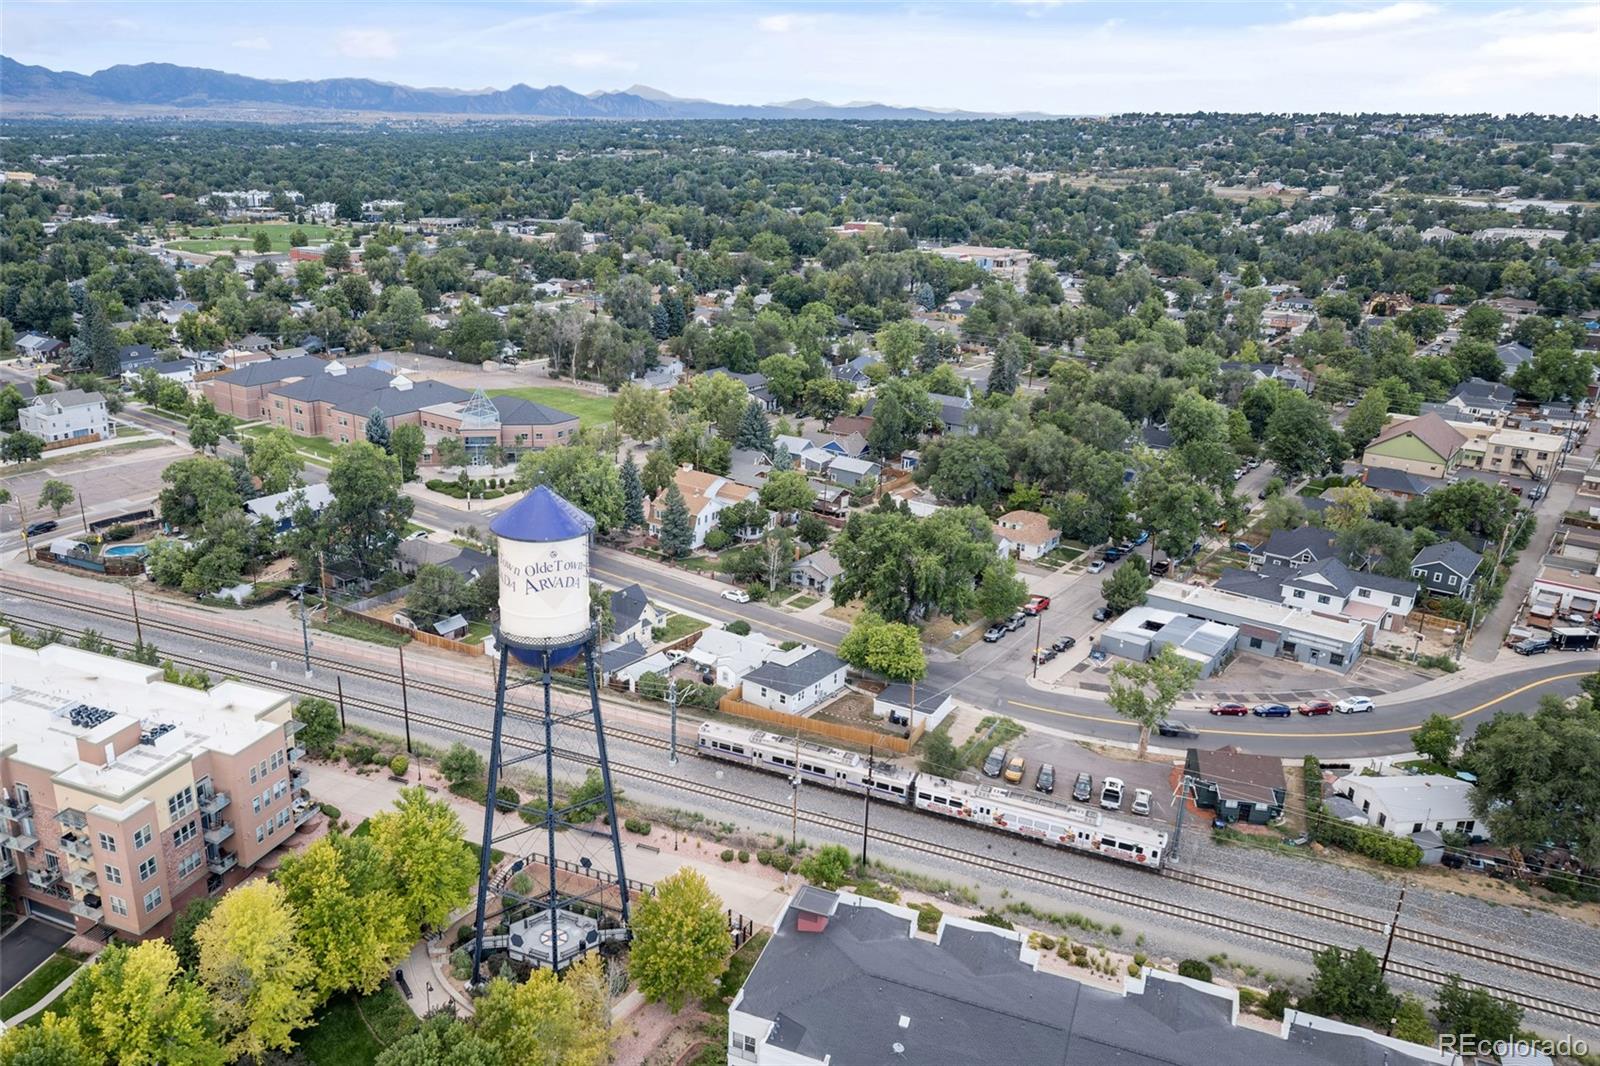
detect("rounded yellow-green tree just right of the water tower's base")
[629,868,733,1013]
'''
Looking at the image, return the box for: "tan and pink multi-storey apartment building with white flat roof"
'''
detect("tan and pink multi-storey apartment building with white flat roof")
[0,631,317,936]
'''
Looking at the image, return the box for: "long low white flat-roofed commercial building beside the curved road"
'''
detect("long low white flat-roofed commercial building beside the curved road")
[1146,579,1366,674]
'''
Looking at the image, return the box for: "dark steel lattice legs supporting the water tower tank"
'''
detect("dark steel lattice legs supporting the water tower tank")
[472,635,629,984]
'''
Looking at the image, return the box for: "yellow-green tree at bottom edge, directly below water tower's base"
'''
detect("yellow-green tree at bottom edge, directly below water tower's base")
[475,946,611,1066]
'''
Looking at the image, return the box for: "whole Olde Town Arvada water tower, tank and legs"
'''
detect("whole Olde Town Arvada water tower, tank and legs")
[472,485,629,984]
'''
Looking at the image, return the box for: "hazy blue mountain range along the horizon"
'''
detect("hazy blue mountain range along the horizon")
[0,56,1045,120]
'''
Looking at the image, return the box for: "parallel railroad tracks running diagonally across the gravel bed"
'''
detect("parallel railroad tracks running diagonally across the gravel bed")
[10,589,1600,1028]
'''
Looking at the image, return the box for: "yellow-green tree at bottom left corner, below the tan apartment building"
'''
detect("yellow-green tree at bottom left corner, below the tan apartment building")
[59,940,229,1066]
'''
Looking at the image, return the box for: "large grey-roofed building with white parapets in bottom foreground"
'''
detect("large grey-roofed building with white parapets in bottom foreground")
[728,885,1459,1066]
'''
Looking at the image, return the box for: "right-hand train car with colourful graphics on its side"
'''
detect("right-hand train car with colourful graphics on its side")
[915,773,1166,869]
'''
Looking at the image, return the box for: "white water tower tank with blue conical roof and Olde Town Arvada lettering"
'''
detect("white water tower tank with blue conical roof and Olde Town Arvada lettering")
[490,485,594,658]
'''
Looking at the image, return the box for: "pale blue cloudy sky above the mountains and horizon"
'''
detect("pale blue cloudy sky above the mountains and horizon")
[9,0,1600,114]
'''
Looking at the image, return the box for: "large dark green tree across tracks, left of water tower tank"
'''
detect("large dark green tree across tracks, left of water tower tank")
[321,440,413,573]
